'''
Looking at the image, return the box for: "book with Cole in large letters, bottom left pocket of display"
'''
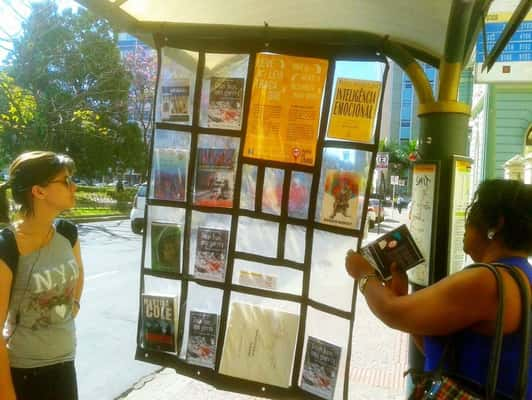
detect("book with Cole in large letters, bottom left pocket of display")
[142,294,178,353]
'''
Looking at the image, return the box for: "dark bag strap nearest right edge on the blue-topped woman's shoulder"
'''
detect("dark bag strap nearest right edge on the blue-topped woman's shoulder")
[493,263,532,399]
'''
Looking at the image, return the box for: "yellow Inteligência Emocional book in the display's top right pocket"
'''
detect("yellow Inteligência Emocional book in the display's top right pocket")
[327,78,381,142]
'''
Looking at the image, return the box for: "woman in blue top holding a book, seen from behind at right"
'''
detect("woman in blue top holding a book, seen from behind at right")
[346,180,532,399]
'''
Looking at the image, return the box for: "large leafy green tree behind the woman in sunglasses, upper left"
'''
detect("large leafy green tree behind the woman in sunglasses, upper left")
[3,0,145,178]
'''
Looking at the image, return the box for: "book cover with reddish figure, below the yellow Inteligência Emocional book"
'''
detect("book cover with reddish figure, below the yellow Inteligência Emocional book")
[320,169,360,229]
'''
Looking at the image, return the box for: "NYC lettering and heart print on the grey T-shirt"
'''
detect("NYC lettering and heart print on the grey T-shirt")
[24,259,79,330]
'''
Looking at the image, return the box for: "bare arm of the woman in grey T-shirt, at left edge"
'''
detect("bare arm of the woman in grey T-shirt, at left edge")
[0,260,16,400]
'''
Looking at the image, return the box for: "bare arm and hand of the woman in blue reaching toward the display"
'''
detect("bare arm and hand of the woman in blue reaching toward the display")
[346,252,497,335]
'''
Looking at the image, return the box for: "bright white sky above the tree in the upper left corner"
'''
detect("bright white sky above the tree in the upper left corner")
[0,0,80,65]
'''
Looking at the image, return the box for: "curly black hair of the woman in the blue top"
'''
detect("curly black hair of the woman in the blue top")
[466,179,532,254]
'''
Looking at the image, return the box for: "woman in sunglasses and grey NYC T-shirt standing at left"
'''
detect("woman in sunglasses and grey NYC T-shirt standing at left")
[0,151,83,400]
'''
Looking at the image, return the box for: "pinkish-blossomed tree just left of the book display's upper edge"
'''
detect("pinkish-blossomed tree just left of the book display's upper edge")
[123,44,157,143]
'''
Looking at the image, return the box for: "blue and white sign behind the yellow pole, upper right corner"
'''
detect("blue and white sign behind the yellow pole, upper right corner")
[475,11,532,83]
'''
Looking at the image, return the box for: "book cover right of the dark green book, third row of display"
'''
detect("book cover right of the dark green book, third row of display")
[194,227,229,282]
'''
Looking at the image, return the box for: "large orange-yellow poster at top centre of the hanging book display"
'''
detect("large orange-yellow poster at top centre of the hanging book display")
[244,54,328,165]
